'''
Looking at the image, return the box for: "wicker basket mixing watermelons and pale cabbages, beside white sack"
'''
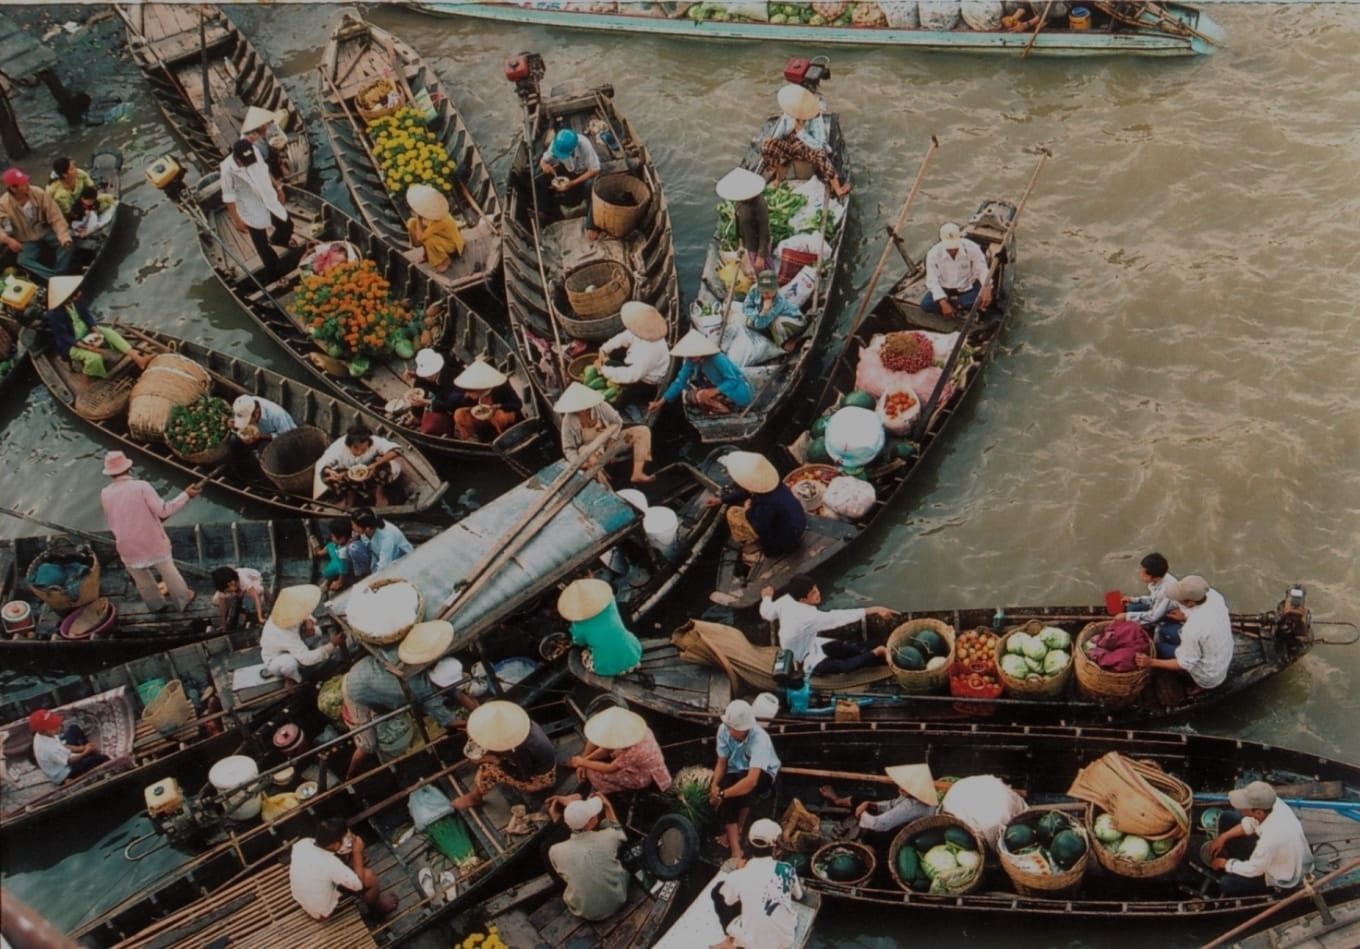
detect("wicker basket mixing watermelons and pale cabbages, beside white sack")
[888,814,987,896]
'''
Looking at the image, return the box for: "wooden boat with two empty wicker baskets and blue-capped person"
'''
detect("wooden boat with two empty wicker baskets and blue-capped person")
[503,53,680,418]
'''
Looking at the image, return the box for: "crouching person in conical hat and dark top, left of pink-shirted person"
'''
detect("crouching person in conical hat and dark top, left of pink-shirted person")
[453,699,558,810]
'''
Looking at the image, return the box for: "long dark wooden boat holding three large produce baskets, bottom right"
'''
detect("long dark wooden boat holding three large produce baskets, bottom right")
[635,722,1360,922]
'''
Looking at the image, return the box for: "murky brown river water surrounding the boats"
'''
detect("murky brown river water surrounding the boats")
[0,4,1360,949]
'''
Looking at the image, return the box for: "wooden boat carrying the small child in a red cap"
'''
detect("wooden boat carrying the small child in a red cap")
[0,631,299,832]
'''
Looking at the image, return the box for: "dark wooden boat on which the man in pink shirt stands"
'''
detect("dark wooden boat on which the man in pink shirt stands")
[0,521,311,658]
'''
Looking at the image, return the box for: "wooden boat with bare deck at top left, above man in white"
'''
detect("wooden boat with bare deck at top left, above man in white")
[113,3,311,185]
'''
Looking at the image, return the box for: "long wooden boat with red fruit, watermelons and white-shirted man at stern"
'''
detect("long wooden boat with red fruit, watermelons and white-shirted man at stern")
[711,200,1016,609]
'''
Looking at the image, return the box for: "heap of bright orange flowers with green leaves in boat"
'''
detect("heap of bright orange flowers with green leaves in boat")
[294,260,412,359]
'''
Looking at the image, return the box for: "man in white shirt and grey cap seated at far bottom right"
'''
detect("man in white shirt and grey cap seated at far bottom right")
[1209,780,1312,897]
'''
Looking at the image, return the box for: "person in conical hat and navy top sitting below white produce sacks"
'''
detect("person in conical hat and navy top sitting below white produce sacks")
[704,451,808,563]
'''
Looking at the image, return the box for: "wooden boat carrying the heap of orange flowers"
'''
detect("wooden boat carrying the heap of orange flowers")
[164,171,558,475]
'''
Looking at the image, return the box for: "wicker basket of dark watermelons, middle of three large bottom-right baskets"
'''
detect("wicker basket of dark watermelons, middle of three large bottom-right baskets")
[997,808,1091,899]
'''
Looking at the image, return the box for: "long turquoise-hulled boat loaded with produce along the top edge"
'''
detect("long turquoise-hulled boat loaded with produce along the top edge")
[412,0,1223,57]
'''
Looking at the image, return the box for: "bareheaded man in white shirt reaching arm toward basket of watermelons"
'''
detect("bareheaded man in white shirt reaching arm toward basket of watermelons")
[760,574,892,676]
